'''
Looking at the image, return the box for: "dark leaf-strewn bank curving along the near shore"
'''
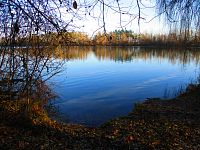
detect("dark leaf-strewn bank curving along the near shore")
[0,85,200,149]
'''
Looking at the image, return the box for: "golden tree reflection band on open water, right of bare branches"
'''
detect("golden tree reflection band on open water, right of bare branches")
[54,47,200,65]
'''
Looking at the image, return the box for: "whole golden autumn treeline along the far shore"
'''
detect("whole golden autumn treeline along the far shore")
[0,30,200,47]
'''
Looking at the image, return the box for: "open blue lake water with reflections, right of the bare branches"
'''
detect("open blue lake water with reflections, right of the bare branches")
[49,47,200,126]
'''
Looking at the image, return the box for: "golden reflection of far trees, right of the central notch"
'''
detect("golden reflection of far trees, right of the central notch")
[95,47,200,65]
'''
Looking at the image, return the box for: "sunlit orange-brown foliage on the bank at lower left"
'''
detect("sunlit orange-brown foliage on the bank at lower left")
[0,99,61,130]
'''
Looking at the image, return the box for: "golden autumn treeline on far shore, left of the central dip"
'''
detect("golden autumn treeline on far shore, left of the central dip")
[0,32,92,46]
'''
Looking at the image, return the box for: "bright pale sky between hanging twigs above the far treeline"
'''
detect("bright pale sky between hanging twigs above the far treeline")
[69,0,167,35]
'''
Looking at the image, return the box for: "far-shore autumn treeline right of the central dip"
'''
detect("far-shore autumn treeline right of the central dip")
[93,30,200,47]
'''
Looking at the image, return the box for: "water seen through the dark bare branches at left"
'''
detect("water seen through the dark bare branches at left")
[0,47,63,100]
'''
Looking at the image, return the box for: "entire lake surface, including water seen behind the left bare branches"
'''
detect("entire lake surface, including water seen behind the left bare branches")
[0,46,200,126]
